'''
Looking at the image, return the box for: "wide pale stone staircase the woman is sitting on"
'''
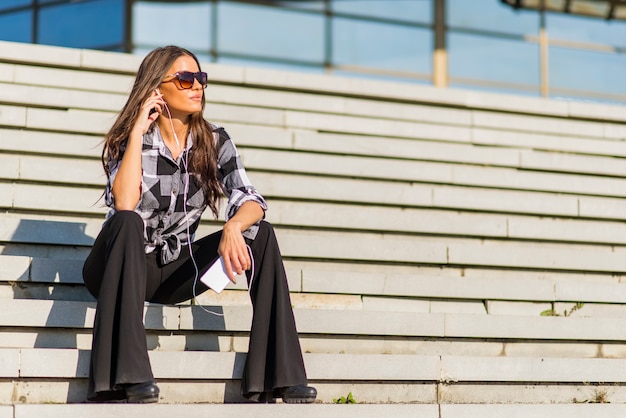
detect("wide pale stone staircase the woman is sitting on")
[0,38,626,418]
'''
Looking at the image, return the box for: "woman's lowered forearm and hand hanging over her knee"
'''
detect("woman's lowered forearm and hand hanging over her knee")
[218,200,265,283]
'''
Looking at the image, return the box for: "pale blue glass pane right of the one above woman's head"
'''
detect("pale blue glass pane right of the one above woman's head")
[217,3,324,63]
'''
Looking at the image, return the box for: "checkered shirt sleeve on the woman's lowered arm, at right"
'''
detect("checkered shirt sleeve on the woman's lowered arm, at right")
[213,127,267,239]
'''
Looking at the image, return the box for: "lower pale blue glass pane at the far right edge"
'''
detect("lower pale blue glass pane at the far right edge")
[549,47,626,94]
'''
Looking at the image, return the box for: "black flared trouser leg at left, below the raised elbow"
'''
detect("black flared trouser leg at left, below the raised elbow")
[83,211,153,399]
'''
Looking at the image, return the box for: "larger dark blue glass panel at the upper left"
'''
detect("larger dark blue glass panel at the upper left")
[37,0,124,48]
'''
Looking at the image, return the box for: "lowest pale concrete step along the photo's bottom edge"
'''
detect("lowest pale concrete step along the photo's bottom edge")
[6,404,626,418]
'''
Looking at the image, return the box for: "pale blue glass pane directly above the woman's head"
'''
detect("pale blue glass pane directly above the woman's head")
[132,1,212,53]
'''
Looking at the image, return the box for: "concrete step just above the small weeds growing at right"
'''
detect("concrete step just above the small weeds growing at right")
[7,255,626,306]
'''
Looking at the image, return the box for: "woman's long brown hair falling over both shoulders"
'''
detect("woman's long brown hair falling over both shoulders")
[102,45,222,218]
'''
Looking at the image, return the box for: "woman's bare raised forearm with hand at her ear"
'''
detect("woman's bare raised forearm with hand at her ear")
[111,92,163,210]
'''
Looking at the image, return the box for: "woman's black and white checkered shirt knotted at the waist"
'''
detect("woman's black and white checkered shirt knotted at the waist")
[104,122,267,264]
